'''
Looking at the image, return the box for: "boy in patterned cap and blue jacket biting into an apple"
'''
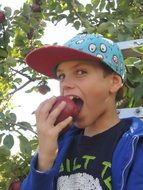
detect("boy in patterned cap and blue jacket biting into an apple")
[21,33,143,190]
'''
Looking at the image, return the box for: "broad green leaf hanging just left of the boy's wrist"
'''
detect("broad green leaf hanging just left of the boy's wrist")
[19,136,32,155]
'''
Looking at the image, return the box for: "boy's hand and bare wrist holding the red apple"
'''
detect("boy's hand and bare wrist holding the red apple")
[35,97,72,171]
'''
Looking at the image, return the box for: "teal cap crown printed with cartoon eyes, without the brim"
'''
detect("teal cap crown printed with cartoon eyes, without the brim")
[64,33,126,79]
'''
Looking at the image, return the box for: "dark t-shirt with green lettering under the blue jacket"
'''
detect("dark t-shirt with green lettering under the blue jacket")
[57,120,130,190]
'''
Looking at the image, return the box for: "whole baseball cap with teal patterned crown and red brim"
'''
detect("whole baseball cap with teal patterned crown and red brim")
[25,33,126,80]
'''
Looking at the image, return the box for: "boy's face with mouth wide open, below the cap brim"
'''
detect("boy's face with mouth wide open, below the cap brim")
[56,61,119,128]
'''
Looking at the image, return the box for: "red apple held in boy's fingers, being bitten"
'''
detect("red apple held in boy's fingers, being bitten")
[50,96,81,125]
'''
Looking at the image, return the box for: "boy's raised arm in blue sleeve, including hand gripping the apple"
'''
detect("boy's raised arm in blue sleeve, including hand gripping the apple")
[20,97,72,190]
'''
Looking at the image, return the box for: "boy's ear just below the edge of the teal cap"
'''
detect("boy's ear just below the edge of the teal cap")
[110,73,123,93]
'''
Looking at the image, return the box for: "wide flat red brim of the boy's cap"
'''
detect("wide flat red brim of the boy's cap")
[25,46,102,78]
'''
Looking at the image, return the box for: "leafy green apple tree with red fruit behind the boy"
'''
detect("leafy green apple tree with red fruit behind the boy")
[0,0,143,190]
